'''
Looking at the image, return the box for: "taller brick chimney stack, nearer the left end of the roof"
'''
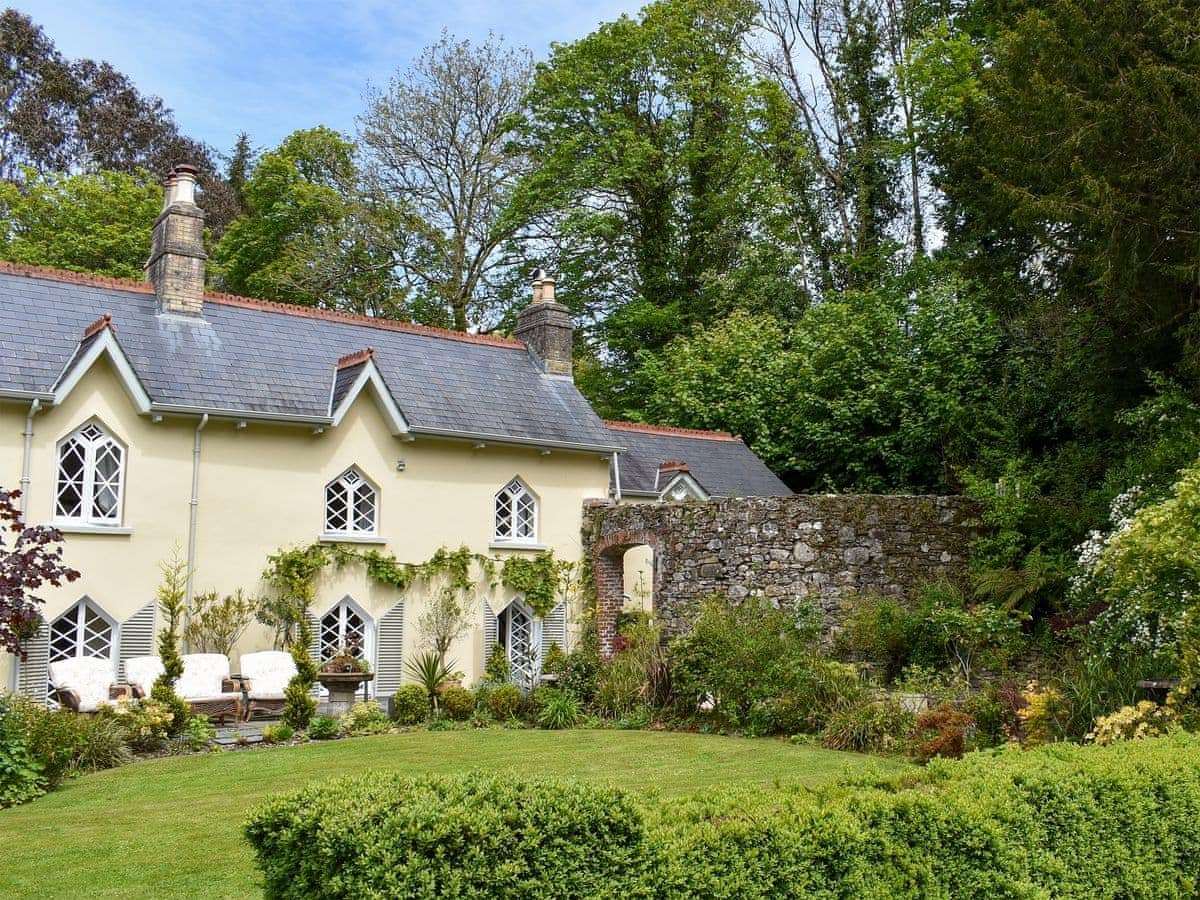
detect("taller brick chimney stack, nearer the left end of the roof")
[145,164,208,316]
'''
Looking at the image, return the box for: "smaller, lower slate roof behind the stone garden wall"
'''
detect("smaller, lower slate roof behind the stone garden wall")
[605,421,792,497]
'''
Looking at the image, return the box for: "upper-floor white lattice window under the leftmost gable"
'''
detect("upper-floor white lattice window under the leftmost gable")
[54,422,125,526]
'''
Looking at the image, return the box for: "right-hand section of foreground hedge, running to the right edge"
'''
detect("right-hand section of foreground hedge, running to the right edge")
[648,737,1200,900]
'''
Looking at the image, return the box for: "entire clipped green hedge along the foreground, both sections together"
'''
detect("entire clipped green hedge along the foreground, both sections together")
[247,736,1200,899]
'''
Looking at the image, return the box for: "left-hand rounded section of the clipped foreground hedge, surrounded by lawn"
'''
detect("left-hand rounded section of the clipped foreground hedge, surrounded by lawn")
[246,773,649,898]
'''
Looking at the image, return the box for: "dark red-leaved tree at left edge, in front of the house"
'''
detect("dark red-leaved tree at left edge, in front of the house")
[0,487,79,659]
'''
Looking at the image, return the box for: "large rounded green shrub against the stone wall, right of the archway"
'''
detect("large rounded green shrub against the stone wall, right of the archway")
[667,596,812,727]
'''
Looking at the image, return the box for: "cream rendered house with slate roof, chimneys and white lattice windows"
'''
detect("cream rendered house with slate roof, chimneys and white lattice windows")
[0,166,786,697]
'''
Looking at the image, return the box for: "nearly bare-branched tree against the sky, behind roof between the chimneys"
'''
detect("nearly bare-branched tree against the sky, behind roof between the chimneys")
[360,34,533,330]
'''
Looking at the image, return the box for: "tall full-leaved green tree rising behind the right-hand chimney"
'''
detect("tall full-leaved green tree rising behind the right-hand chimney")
[515,0,803,413]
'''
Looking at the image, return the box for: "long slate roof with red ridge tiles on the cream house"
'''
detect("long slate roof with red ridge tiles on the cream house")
[0,264,622,450]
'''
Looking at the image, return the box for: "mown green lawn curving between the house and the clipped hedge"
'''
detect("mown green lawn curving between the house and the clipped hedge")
[0,728,900,898]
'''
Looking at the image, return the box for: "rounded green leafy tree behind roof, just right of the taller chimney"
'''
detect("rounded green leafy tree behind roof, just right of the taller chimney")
[212,127,404,316]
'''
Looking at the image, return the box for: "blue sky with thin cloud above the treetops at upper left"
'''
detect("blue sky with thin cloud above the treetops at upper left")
[10,0,644,157]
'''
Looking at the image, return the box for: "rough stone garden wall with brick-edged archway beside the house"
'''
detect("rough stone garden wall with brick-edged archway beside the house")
[583,494,979,653]
